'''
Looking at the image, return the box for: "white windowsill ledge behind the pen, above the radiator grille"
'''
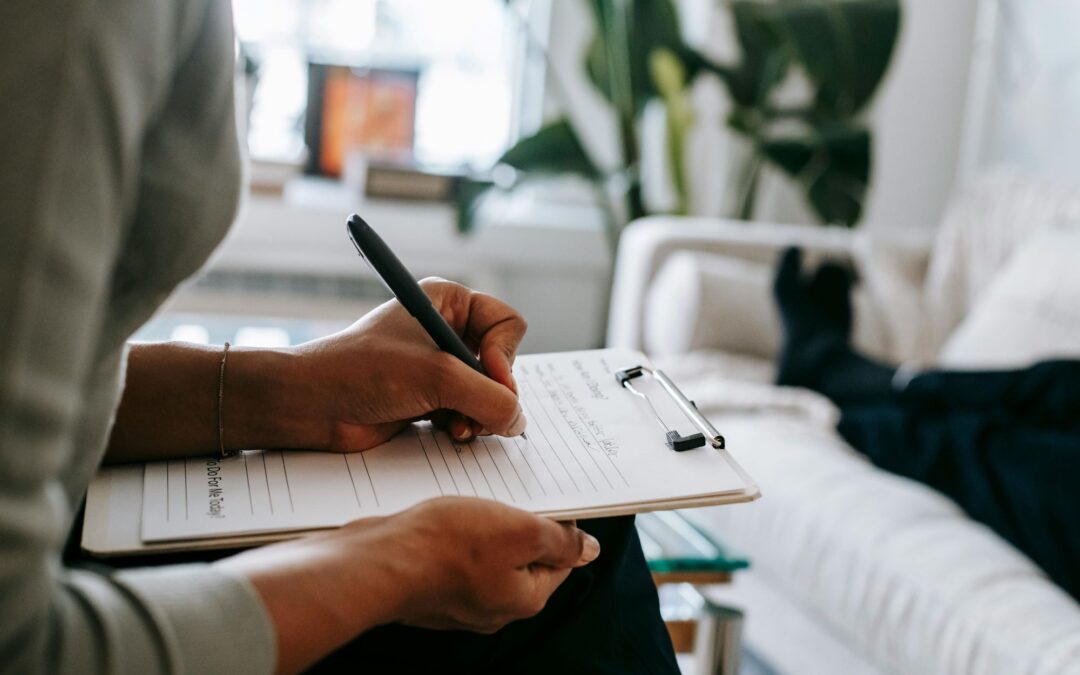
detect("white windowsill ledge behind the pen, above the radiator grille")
[211,178,610,278]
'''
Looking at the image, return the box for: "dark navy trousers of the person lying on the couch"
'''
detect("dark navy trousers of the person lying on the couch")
[839,361,1080,599]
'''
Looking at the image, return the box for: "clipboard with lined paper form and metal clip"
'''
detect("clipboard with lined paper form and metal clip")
[82,349,760,557]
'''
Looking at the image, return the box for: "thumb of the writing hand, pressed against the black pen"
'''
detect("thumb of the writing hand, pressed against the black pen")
[435,356,526,436]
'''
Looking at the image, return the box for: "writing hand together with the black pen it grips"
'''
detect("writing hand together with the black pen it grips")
[250,214,526,453]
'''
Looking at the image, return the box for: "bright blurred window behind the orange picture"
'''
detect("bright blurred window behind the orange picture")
[233,0,539,166]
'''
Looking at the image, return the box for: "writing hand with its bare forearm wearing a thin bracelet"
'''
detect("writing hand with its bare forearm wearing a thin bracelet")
[107,218,526,461]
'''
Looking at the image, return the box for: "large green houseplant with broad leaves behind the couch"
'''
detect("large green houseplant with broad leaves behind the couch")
[458,0,901,245]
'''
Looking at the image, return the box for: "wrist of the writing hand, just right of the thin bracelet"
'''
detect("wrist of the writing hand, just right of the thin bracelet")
[222,347,330,449]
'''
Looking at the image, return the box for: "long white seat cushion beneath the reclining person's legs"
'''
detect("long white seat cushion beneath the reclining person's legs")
[666,356,1080,675]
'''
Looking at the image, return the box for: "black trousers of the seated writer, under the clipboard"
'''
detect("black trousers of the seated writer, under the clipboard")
[67,514,679,675]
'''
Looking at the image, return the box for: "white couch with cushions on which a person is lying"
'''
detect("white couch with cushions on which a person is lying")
[609,174,1080,675]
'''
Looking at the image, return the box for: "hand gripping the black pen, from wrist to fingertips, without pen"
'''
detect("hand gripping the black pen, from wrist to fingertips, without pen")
[285,279,526,453]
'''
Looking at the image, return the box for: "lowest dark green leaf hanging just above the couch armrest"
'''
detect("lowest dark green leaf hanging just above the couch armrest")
[758,124,870,227]
